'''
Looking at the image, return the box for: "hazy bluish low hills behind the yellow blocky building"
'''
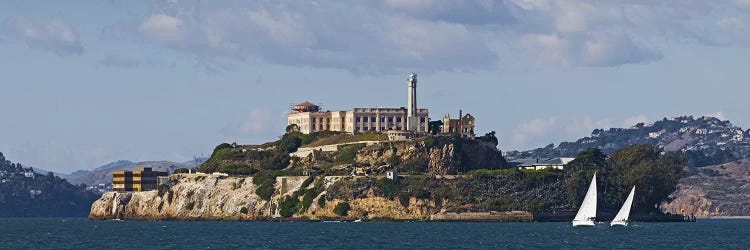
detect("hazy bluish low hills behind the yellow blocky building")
[68,160,200,189]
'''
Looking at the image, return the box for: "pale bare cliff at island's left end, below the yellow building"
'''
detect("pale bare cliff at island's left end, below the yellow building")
[89,175,269,220]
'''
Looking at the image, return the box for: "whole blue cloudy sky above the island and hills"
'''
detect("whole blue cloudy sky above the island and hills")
[0,0,750,172]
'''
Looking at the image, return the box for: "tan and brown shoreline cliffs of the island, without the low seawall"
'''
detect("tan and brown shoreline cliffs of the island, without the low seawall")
[89,175,435,220]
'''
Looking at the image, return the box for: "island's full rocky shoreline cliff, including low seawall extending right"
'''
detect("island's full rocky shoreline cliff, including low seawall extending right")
[89,174,531,221]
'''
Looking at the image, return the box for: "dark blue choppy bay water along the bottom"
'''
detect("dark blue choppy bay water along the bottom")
[0,219,750,249]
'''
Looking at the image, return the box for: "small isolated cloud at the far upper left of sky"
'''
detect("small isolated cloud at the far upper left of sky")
[0,17,83,56]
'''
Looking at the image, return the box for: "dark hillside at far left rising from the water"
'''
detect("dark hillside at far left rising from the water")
[0,153,98,217]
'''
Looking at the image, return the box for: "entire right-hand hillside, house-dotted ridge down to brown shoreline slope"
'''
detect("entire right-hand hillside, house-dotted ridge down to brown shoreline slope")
[506,116,750,216]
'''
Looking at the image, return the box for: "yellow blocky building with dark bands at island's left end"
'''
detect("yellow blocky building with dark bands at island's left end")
[112,168,169,192]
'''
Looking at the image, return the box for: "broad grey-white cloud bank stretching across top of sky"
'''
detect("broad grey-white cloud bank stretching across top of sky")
[103,0,750,74]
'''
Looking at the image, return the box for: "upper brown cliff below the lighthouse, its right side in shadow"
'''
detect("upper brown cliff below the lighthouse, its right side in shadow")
[355,138,507,175]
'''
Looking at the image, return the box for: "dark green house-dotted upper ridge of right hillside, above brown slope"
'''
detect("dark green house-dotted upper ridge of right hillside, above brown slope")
[506,116,750,167]
